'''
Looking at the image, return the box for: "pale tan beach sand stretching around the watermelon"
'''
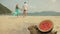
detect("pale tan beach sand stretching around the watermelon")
[0,16,60,34]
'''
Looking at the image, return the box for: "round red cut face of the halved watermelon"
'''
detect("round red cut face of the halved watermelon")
[39,20,52,31]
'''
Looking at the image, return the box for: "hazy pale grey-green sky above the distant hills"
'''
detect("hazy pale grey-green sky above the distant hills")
[0,0,60,12]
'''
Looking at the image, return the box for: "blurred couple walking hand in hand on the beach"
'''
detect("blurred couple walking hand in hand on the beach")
[13,2,28,17]
